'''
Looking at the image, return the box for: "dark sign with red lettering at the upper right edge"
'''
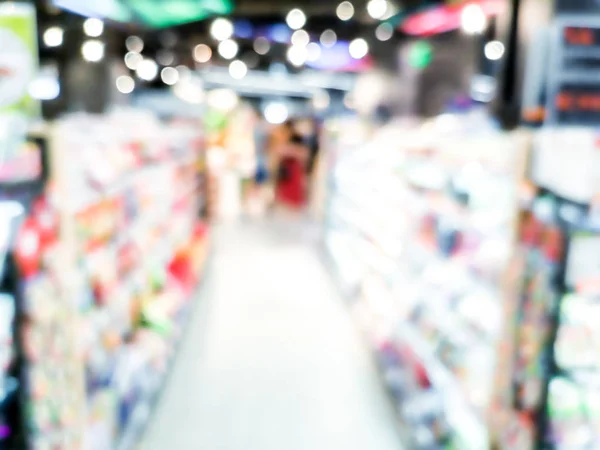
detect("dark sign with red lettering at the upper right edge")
[546,15,600,127]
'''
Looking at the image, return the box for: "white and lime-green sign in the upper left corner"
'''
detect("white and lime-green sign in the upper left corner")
[0,2,39,120]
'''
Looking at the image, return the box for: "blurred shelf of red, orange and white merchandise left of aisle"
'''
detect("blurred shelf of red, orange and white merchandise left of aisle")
[0,111,208,450]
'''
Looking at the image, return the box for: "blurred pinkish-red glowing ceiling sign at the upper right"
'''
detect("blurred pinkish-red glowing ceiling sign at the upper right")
[400,0,506,36]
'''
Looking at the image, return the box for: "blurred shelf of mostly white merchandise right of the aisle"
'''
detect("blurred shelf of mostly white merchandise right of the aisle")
[325,112,522,450]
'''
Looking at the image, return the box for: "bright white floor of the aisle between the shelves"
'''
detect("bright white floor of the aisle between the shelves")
[142,220,400,450]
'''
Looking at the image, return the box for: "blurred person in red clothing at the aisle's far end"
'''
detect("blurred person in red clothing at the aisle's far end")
[275,121,310,209]
